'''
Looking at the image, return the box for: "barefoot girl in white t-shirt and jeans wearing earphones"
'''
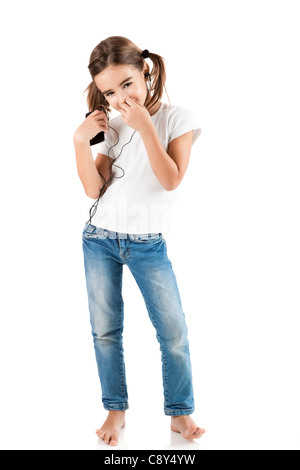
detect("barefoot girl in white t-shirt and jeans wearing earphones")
[74,36,205,445]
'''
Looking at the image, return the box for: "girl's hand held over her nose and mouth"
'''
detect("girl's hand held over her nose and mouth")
[121,98,153,132]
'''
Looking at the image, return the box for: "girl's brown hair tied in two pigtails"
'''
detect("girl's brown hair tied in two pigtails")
[84,36,170,114]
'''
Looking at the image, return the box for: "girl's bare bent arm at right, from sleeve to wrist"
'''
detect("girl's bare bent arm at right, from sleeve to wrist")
[140,123,194,191]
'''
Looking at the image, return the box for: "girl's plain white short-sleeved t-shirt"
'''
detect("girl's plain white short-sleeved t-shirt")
[91,102,201,234]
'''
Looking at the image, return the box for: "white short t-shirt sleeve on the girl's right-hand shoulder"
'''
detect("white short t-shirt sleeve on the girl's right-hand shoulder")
[169,106,202,144]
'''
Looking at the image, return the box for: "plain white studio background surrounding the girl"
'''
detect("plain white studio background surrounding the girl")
[0,0,300,450]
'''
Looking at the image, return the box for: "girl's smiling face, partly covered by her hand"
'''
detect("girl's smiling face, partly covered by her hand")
[94,64,149,112]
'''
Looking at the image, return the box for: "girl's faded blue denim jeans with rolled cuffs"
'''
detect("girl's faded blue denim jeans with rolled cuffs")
[82,223,194,416]
